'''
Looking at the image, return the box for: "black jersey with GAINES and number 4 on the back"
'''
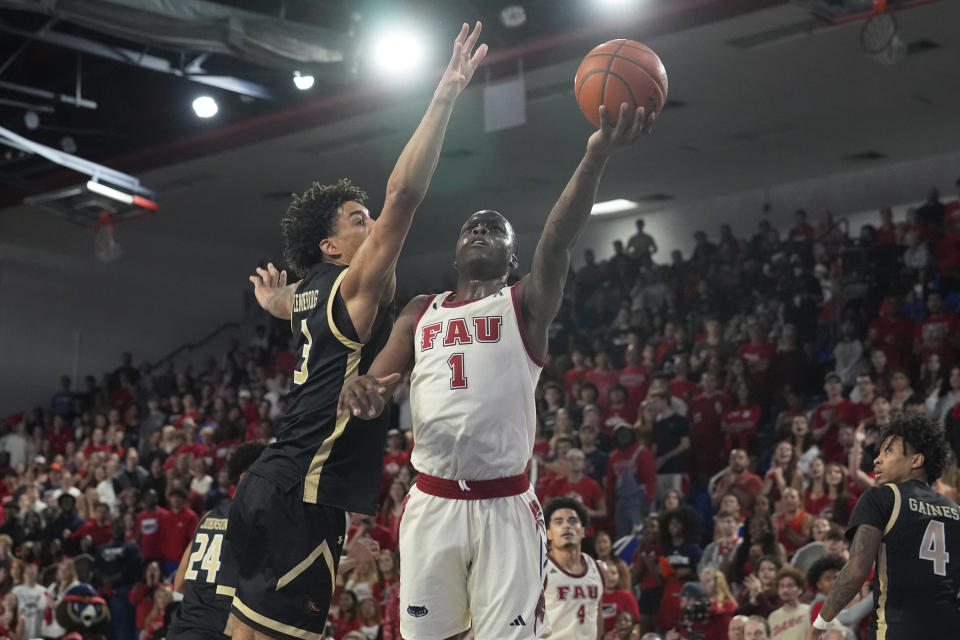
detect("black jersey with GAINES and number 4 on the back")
[847,480,960,640]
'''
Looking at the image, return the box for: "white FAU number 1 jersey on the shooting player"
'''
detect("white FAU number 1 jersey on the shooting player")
[410,286,542,480]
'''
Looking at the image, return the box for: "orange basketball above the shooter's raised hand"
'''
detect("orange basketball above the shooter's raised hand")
[574,38,667,127]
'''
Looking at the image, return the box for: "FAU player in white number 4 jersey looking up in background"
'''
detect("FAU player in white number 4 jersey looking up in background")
[543,498,603,640]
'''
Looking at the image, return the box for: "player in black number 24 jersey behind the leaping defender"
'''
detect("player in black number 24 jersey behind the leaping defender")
[167,442,266,640]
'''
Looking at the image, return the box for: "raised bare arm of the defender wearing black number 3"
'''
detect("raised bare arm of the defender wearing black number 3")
[340,22,487,341]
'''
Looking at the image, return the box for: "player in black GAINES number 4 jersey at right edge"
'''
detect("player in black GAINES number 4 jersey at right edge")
[807,415,960,640]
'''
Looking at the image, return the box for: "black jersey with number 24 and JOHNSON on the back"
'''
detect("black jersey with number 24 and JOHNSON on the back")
[167,500,237,640]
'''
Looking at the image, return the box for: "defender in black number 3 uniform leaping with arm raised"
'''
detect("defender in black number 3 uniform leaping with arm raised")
[227,22,487,640]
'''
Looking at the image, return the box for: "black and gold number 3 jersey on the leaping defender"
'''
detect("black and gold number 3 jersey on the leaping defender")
[250,263,392,515]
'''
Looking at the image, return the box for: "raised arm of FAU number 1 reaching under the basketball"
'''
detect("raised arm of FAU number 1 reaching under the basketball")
[519,104,655,356]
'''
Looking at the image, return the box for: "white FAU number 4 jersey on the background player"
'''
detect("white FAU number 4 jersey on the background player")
[545,553,603,640]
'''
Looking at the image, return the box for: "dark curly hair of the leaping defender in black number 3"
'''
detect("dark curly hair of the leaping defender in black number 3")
[280,178,367,277]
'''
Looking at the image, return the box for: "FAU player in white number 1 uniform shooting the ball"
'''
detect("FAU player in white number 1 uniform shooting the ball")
[339,104,654,640]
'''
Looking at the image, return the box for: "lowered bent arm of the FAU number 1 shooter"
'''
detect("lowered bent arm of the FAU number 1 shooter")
[337,296,428,419]
